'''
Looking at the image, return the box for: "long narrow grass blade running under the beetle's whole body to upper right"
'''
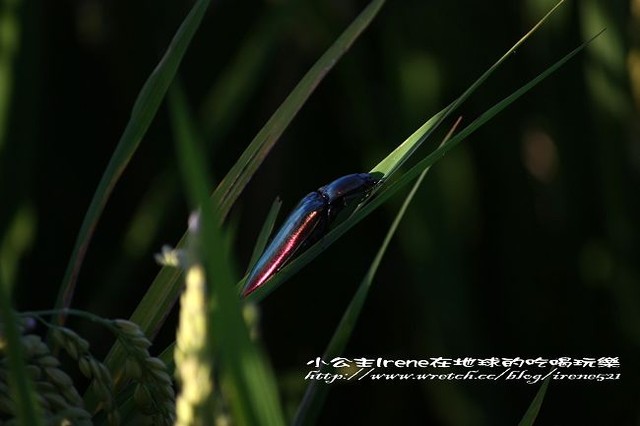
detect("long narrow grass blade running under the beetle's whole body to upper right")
[238,32,602,302]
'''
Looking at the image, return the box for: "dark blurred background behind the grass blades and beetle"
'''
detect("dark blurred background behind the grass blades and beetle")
[0,0,640,425]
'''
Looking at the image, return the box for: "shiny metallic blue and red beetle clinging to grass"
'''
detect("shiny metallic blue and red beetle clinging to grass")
[242,173,381,297]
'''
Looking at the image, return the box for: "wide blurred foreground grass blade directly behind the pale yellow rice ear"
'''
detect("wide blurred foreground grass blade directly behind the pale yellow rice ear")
[171,83,284,425]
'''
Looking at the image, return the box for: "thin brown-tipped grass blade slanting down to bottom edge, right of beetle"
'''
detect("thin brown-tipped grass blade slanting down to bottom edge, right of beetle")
[293,119,460,425]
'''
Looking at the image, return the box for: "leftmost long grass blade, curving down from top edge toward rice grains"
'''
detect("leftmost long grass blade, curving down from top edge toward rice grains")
[55,0,210,321]
